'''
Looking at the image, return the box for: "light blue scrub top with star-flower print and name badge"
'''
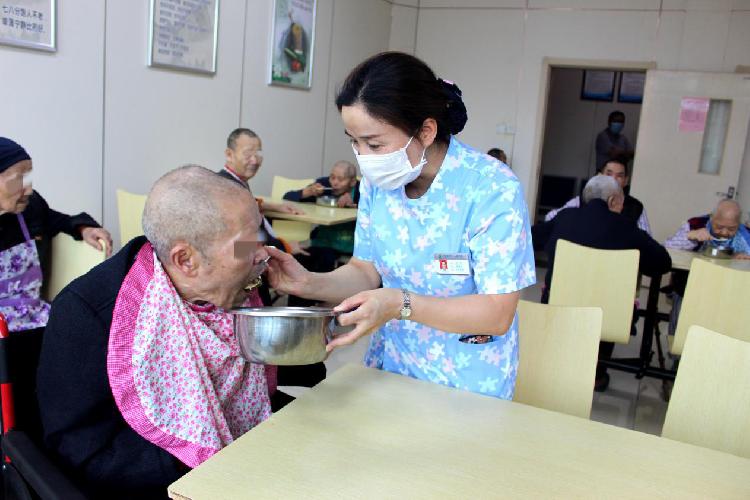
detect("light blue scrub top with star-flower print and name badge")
[354,138,536,399]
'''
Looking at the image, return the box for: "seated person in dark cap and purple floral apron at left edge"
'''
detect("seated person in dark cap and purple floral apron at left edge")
[0,137,112,438]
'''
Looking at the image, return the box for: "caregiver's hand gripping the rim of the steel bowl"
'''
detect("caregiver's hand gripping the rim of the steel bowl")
[326,288,403,352]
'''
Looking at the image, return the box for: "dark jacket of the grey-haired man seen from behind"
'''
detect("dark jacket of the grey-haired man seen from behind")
[531,200,672,298]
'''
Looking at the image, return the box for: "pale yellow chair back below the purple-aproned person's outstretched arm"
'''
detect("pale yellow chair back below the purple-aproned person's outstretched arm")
[45,233,106,302]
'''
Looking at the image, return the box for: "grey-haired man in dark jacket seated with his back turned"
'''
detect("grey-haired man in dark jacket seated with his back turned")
[532,175,672,391]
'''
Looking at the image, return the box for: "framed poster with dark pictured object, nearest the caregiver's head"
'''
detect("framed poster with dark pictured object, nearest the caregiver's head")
[268,0,316,89]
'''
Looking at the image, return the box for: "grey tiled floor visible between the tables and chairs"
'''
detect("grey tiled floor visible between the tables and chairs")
[283,268,672,434]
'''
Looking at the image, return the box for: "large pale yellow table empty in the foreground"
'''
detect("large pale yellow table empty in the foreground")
[169,365,750,500]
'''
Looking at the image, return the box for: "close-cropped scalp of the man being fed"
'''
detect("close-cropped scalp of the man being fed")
[142,165,260,263]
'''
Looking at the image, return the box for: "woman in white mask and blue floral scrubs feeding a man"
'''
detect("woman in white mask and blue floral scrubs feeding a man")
[269,52,535,399]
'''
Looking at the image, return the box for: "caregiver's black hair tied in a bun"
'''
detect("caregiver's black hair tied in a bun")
[336,52,467,144]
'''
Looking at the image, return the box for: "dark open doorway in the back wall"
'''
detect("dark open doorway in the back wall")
[534,64,648,222]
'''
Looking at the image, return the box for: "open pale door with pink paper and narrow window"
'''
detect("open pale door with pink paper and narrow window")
[631,70,750,243]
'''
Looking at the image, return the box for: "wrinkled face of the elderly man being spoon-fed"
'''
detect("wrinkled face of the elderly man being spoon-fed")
[197,196,268,309]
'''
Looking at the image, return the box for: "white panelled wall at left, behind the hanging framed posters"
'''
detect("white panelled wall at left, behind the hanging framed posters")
[0,0,391,246]
